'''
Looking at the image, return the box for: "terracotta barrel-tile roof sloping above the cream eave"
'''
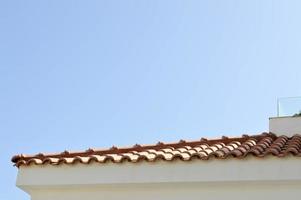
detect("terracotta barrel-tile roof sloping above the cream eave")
[12,133,301,167]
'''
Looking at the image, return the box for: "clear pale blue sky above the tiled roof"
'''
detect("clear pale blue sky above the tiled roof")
[0,0,301,200]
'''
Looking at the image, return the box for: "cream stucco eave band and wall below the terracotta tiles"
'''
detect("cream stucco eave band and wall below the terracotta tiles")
[17,156,301,200]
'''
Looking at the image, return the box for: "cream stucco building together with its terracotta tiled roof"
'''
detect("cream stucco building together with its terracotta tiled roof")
[12,118,301,200]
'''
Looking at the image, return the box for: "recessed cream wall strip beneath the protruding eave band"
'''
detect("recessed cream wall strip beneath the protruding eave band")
[32,182,301,200]
